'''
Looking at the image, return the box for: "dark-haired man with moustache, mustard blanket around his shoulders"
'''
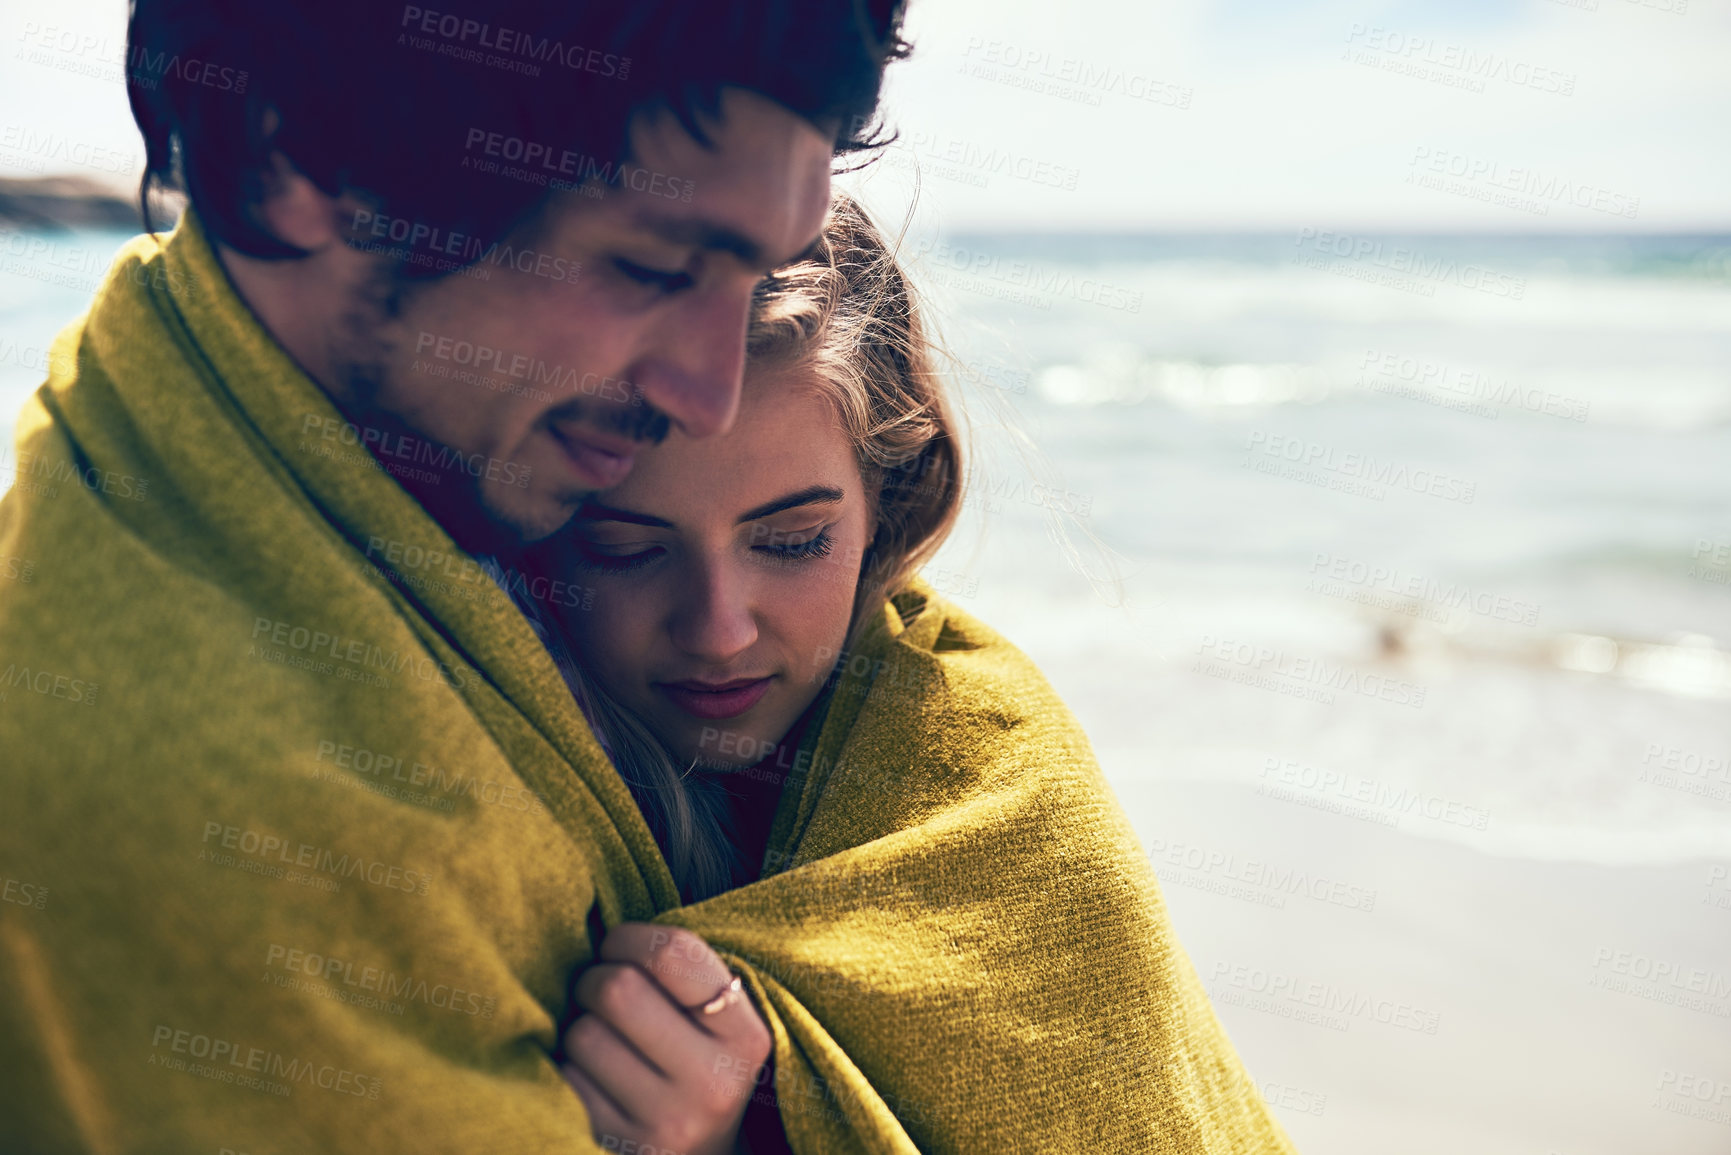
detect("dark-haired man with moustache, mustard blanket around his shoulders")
[0,0,904,1153]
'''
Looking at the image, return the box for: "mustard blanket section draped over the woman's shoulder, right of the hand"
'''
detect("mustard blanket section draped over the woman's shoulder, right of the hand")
[661,582,1291,1153]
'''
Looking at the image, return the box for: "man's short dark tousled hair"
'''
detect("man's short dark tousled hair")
[126,0,907,277]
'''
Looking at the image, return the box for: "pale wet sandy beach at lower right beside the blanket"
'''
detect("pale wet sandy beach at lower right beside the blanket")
[1118,783,1731,1155]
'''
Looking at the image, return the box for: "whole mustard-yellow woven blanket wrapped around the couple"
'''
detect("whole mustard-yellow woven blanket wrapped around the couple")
[0,215,1290,1155]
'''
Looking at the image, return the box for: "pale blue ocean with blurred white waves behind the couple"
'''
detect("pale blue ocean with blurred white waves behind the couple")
[0,230,1731,864]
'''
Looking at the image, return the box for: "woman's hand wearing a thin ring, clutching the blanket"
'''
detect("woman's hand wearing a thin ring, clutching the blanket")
[559,923,770,1155]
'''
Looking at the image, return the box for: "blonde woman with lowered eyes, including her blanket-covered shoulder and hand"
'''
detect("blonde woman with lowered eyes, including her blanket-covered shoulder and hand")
[542,197,1286,1152]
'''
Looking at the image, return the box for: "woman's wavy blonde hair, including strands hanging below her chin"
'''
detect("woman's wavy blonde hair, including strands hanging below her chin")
[576,194,962,902]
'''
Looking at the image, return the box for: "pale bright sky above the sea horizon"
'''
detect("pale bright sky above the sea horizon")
[0,0,1731,232]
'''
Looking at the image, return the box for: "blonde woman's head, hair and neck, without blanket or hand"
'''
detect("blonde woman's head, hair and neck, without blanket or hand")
[540,197,961,902]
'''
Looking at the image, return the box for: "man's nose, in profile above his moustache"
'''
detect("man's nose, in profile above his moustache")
[632,281,751,438]
